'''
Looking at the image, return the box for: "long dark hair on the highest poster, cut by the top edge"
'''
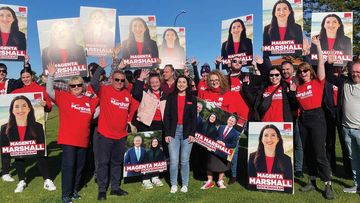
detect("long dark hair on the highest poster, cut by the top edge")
[268,0,299,39]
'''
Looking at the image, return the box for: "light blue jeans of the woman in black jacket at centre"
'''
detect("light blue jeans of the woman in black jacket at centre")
[169,125,193,186]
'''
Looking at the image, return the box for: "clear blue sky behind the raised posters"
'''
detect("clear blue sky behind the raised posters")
[0,0,262,78]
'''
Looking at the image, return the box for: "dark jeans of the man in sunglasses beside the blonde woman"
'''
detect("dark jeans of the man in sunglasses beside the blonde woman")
[97,133,126,192]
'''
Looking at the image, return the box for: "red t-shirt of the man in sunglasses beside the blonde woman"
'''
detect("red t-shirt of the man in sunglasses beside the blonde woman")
[98,85,138,139]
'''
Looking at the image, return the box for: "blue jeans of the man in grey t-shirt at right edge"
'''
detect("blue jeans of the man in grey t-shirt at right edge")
[343,126,360,188]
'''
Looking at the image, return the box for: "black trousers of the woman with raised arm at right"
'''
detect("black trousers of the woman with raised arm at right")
[299,108,331,181]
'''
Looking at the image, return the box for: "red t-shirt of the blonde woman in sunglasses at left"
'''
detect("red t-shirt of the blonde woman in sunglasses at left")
[55,90,99,148]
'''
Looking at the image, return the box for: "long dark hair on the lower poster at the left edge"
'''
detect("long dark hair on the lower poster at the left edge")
[5,95,36,138]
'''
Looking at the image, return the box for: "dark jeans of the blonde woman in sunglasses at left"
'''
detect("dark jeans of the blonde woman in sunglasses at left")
[61,145,87,197]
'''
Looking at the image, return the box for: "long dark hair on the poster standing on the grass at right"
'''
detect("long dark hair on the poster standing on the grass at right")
[254,124,285,171]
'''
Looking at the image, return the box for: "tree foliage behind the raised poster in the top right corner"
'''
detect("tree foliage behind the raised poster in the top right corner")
[304,0,360,55]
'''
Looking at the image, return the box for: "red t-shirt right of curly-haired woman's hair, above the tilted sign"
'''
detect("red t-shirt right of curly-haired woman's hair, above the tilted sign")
[221,91,249,126]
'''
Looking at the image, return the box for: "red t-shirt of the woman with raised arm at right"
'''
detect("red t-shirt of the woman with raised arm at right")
[296,79,325,110]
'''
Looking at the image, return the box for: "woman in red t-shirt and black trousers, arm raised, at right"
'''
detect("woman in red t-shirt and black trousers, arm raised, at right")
[296,37,334,199]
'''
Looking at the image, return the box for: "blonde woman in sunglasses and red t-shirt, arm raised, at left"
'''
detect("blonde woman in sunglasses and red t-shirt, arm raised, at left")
[46,63,99,202]
